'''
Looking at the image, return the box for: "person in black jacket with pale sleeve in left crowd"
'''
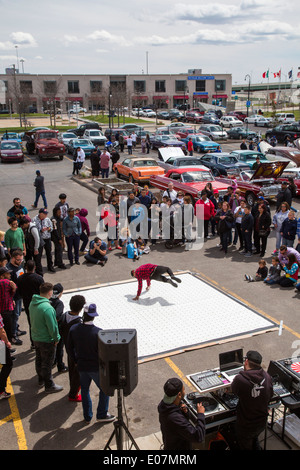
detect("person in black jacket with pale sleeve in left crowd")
[20,217,43,276]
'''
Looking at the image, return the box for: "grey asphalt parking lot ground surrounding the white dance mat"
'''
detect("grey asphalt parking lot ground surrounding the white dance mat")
[0,136,300,450]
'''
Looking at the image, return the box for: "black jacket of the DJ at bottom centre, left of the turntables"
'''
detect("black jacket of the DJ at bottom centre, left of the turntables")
[158,401,205,450]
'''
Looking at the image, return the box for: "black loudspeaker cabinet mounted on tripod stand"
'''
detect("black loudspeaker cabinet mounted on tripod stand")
[98,329,138,396]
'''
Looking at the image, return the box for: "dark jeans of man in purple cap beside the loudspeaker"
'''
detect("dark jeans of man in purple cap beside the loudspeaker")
[79,371,109,421]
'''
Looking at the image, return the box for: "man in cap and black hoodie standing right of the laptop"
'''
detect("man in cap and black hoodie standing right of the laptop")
[231,350,273,450]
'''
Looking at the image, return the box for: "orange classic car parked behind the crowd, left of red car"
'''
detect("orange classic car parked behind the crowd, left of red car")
[114,157,164,183]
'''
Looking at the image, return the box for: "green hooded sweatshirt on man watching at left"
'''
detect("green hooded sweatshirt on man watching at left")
[29,294,60,343]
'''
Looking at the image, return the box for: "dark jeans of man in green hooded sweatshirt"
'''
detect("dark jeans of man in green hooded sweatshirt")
[33,341,56,389]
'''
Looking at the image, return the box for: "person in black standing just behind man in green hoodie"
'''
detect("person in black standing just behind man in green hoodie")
[17,260,44,349]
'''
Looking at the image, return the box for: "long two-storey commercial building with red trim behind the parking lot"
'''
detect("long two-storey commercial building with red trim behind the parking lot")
[0,69,232,112]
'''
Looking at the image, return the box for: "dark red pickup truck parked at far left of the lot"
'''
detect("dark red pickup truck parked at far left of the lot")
[26,130,66,160]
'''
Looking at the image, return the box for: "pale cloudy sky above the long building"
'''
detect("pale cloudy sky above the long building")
[0,0,300,84]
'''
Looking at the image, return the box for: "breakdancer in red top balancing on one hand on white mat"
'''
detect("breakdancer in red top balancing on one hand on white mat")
[131,264,181,300]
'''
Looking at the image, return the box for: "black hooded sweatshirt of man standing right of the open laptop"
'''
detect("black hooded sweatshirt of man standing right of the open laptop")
[231,367,273,431]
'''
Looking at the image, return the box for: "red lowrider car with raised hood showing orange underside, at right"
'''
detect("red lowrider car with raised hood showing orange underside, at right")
[216,161,289,206]
